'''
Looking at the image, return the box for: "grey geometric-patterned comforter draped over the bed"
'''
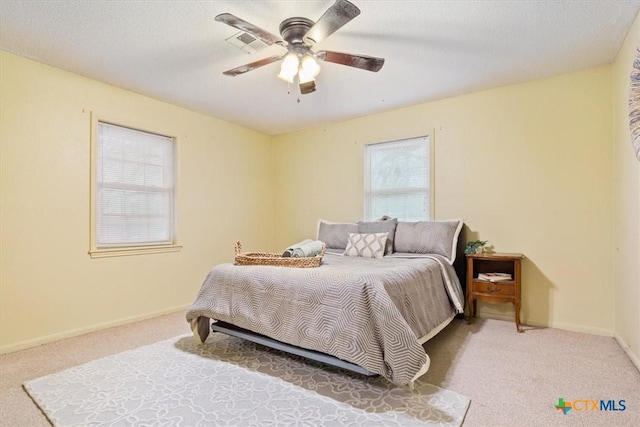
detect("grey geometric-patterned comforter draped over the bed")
[187,254,464,385]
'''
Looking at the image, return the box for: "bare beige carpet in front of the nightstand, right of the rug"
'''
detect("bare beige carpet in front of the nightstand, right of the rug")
[424,319,640,427]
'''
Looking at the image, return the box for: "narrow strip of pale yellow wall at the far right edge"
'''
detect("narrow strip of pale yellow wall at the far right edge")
[613,15,640,369]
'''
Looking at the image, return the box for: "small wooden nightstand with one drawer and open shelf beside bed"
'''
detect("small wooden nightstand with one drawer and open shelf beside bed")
[467,253,524,332]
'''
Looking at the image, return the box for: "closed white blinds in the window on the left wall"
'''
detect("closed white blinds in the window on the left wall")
[95,122,175,248]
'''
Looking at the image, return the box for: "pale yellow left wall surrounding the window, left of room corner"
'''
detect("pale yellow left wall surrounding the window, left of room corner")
[0,52,274,351]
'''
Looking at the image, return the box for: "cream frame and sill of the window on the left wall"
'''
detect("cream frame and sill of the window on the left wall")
[89,113,182,258]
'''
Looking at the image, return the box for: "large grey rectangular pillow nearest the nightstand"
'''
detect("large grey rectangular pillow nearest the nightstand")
[393,219,462,264]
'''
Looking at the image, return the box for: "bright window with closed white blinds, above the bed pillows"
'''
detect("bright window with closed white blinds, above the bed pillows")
[364,136,433,221]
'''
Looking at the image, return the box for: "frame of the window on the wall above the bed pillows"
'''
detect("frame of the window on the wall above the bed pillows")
[363,131,435,221]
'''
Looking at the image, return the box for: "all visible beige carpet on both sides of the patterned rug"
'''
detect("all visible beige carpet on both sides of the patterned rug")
[0,313,640,427]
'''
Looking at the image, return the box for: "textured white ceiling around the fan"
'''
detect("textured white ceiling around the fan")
[0,0,640,134]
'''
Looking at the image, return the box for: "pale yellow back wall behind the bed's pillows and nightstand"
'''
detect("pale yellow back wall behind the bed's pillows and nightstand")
[274,66,614,335]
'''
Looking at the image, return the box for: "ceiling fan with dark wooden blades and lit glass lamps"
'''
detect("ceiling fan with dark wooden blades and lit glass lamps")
[215,0,384,94]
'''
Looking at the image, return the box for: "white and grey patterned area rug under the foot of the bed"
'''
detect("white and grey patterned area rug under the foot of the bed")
[24,333,469,427]
